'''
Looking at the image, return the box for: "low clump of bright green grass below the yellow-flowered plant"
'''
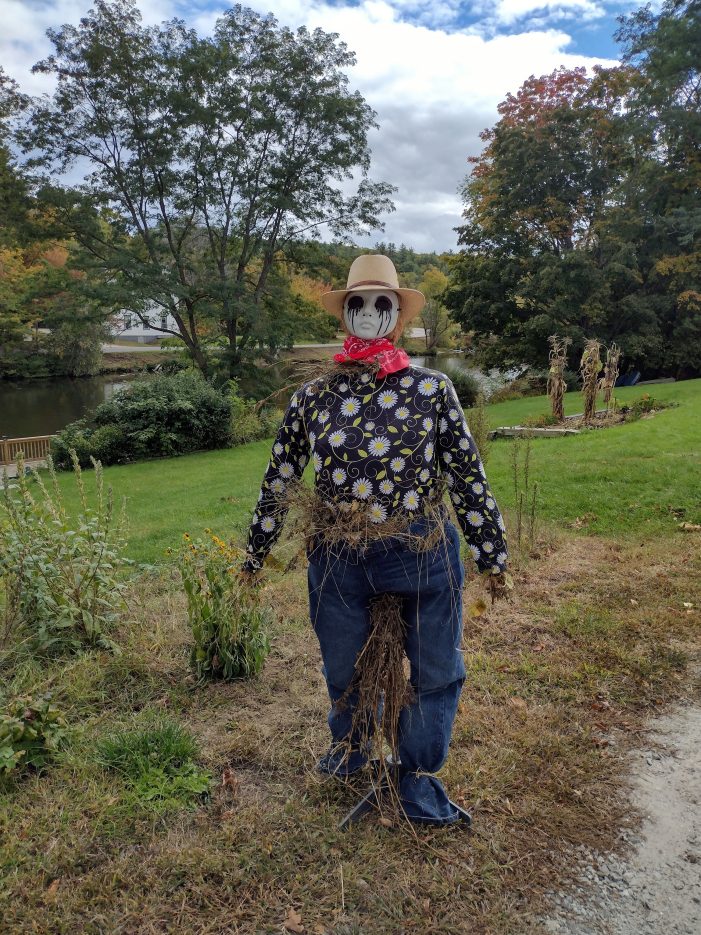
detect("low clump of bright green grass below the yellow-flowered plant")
[97,720,212,808]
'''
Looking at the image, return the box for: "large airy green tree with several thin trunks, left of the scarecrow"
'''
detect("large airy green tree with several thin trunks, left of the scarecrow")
[22,0,392,374]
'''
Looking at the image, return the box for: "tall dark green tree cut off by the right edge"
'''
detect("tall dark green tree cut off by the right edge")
[616,0,701,375]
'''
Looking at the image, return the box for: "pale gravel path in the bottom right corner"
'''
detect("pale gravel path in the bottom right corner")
[540,705,701,935]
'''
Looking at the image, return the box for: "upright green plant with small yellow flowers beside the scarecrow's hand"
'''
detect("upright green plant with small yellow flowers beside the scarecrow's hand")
[180,533,272,681]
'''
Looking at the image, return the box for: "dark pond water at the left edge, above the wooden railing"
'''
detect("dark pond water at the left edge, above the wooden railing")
[0,374,132,438]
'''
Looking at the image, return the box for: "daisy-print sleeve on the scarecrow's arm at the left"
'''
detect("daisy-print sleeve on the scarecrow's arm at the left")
[243,393,310,571]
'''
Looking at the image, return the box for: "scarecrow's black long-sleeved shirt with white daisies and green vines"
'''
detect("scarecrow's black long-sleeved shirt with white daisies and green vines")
[245,367,507,573]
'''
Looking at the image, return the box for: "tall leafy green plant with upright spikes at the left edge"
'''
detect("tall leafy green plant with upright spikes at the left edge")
[0,456,126,654]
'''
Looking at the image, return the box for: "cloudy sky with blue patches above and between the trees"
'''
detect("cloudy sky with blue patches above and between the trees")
[0,0,643,250]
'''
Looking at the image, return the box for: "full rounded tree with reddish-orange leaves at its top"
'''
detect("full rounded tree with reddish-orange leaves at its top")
[445,68,656,367]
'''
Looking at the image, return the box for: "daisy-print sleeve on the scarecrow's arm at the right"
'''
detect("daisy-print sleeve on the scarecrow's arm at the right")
[436,377,508,574]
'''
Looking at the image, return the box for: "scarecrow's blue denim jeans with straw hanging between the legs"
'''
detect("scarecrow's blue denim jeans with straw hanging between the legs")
[307,518,465,824]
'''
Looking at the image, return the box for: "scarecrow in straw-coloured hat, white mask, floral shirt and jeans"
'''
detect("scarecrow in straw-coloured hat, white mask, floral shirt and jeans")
[243,255,509,824]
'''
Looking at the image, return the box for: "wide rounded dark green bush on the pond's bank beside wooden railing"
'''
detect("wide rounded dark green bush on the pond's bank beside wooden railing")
[52,370,231,468]
